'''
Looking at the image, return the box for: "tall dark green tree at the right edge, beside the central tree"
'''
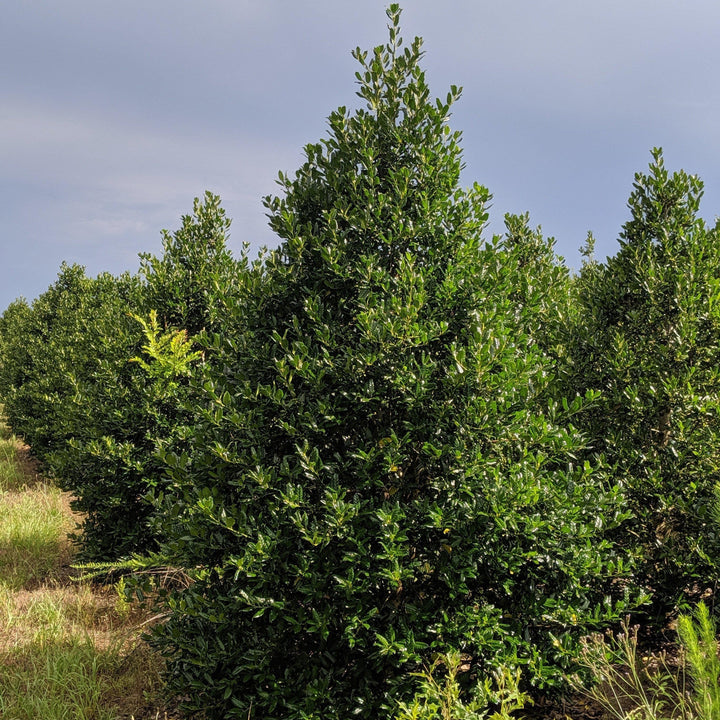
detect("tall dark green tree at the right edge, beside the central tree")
[574,150,720,610]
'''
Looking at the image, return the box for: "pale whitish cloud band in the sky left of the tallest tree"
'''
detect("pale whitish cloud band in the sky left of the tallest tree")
[0,94,300,219]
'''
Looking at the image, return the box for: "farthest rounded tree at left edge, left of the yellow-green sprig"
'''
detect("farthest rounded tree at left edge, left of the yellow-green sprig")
[2,265,139,462]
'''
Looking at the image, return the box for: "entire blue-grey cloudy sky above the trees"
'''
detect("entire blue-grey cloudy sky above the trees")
[0,0,720,310]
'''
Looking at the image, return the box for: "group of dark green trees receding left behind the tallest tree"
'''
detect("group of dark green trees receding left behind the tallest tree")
[0,193,240,560]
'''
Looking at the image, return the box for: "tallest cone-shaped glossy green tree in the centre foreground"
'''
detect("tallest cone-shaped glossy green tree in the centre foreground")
[149,6,623,720]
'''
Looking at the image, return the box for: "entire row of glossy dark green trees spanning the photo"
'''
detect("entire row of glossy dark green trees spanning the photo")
[0,5,720,720]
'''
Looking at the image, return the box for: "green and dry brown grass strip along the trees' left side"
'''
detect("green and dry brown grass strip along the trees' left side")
[0,416,173,720]
